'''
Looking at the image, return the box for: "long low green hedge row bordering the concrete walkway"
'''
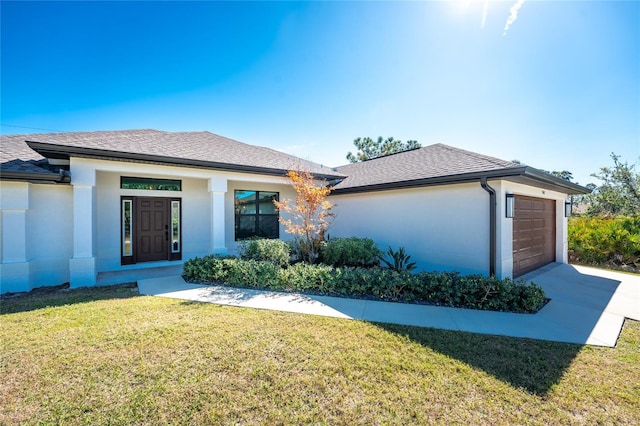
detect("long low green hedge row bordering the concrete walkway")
[183,256,547,313]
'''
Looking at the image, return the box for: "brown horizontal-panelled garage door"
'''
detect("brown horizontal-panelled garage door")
[513,195,556,277]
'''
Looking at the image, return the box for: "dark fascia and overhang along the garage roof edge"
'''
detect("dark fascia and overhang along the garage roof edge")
[331,166,591,195]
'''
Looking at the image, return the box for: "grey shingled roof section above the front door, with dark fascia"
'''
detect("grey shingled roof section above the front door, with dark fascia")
[11,129,343,180]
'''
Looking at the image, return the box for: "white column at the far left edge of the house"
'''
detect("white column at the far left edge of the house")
[0,182,31,293]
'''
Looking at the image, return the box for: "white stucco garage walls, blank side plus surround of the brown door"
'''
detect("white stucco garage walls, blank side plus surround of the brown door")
[329,180,568,278]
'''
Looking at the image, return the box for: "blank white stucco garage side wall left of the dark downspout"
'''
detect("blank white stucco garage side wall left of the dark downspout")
[329,183,489,274]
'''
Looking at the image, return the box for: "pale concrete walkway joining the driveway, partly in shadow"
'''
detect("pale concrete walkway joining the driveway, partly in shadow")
[138,264,640,347]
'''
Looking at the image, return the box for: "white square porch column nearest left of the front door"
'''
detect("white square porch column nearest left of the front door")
[69,169,98,288]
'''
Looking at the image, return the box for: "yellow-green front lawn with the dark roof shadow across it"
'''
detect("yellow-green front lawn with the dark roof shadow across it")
[0,287,640,425]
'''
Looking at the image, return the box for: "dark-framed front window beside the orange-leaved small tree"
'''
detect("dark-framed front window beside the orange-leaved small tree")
[234,191,280,241]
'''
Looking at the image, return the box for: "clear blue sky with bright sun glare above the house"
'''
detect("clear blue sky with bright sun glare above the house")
[0,0,640,184]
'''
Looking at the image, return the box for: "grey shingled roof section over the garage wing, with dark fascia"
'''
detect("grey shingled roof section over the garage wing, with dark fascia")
[333,144,590,195]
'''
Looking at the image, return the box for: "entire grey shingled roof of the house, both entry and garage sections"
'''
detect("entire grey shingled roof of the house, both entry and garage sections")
[0,129,589,195]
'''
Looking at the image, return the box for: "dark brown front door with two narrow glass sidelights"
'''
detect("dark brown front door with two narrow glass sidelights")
[122,197,182,264]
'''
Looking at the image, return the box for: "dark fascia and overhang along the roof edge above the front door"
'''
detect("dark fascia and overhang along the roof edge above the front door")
[26,141,343,180]
